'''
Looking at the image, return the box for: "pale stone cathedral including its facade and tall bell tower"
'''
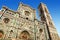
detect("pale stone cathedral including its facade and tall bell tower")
[0,3,60,40]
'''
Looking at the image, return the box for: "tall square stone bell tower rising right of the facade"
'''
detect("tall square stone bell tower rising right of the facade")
[38,3,59,40]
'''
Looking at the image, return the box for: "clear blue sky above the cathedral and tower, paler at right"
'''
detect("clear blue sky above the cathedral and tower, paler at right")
[0,0,60,35]
